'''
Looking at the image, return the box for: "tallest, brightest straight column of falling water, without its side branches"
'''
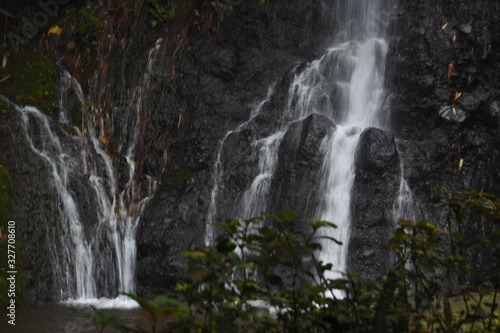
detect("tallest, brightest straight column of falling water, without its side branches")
[317,1,387,279]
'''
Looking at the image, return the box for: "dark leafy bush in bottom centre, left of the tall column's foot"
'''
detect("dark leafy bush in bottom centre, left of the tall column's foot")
[177,213,344,332]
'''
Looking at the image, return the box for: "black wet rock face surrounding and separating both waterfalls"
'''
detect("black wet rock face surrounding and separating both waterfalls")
[0,0,500,302]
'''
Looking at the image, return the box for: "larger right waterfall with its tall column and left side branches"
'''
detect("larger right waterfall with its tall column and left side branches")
[209,0,387,286]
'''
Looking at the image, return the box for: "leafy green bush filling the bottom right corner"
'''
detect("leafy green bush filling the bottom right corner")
[375,188,500,332]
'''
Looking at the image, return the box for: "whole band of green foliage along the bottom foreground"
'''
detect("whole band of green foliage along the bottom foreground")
[85,189,500,333]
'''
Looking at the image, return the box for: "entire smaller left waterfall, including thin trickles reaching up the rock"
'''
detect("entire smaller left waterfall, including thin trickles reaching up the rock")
[6,39,161,307]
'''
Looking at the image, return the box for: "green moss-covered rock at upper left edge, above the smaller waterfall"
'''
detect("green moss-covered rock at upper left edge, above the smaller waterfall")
[0,46,57,115]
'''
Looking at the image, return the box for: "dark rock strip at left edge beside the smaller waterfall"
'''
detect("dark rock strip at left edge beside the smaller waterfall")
[0,108,60,302]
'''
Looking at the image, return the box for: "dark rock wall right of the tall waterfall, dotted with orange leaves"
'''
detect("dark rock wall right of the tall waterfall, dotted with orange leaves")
[386,0,500,221]
